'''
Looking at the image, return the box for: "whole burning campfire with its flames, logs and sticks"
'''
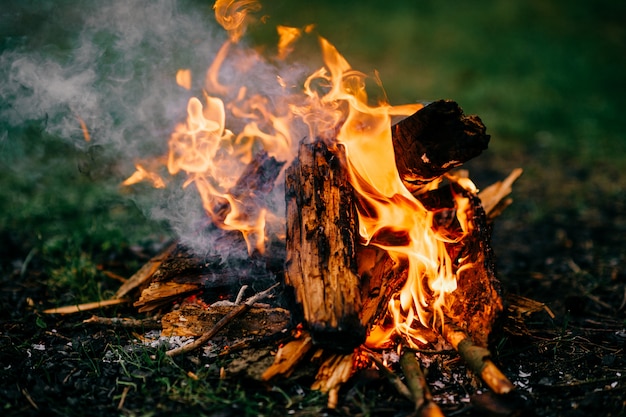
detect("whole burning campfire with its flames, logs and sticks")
[44,0,521,415]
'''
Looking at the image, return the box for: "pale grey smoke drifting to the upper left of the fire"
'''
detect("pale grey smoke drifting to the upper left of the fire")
[0,0,308,258]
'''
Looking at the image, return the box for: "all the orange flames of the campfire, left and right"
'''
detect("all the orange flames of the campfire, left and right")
[125,0,475,347]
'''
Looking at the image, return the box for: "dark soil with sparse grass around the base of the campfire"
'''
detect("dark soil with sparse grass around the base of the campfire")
[0,157,626,417]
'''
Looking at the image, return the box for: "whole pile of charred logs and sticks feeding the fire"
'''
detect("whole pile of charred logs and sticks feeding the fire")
[45,100,521,415]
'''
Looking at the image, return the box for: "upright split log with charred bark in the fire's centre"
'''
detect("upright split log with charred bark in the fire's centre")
[285,141,366,351]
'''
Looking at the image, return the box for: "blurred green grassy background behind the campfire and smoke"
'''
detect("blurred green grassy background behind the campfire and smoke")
[0,0,626,299]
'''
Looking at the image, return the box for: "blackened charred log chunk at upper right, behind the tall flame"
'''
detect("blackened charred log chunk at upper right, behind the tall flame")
[392,100,490,190]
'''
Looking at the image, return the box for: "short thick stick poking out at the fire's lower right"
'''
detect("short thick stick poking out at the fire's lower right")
[441,322,515,394]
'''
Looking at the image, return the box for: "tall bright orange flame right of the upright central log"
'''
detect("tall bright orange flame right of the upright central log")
[294,39,475,346]
